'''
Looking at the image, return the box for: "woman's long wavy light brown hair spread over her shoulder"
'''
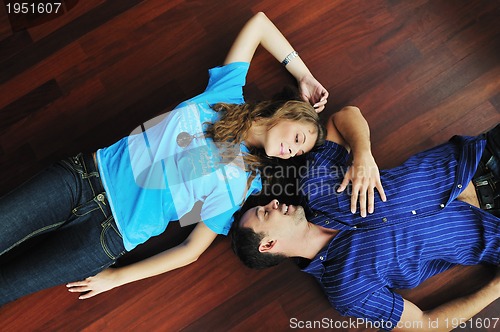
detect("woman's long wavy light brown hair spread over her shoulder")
[206,100,326,183]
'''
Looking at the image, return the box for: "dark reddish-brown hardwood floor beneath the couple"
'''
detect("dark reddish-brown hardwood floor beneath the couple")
[0,0,500,331]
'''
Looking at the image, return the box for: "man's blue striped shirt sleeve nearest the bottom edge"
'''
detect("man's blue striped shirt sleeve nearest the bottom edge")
[339,287,404,331]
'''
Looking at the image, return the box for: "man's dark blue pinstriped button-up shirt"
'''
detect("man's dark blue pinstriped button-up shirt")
[301,136,500,329]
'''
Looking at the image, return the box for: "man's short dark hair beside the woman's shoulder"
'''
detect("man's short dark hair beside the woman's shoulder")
[230,209,287,269]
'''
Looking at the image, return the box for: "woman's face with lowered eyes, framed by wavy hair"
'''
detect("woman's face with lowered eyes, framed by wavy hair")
[264,120,318,159]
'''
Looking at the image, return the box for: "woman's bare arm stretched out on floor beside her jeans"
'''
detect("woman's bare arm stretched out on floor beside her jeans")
[66,222,217,300]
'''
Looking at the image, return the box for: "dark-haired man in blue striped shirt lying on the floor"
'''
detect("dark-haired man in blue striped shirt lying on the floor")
[232,107,500,331]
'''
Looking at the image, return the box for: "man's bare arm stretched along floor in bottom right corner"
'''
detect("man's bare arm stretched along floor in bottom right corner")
[394,268,500,331]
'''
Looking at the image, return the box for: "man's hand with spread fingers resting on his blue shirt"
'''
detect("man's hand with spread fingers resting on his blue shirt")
[337,153,387,217]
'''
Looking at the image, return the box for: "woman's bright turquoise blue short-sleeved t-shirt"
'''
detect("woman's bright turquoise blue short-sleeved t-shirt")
[97,62,262,250]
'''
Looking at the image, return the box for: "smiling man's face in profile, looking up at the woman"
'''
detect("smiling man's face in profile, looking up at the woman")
[240,199,307,237]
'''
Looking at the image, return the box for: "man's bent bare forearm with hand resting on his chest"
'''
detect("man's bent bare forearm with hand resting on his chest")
[326,106,386,217]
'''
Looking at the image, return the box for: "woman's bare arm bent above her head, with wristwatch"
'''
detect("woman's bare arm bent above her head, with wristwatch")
[224,12,328,112]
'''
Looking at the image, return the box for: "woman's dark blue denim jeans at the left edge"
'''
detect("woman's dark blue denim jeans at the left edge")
[0,154,125,305]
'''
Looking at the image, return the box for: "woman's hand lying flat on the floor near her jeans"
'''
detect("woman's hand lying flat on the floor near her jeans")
[66,268,120,300]
